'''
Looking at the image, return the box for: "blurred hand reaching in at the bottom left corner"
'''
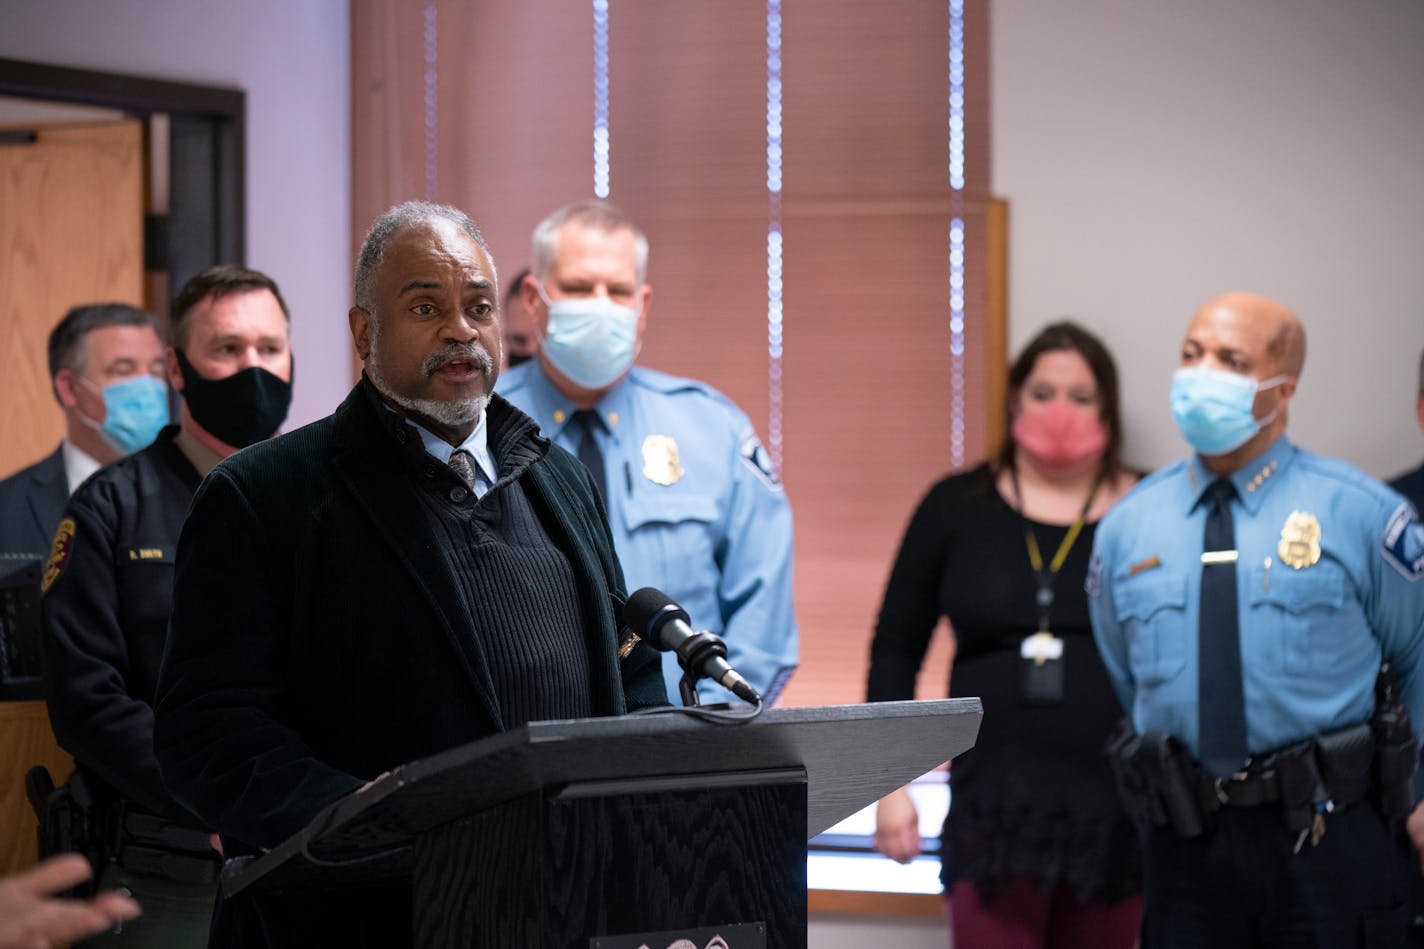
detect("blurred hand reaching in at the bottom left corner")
[0,854,140,949]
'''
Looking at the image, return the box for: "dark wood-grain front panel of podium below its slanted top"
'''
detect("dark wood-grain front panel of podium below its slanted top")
[412,771,806,949]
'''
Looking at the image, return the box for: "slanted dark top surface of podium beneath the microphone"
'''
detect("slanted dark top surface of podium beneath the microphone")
[224,698,983,893]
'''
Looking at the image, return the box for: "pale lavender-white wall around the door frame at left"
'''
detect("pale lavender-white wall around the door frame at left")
[0,0,352,427]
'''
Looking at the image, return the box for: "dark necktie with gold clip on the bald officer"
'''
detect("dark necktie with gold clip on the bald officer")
[1196,480,1246,778]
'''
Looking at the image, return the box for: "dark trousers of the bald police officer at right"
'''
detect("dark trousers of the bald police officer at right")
[1142,804,1408,949]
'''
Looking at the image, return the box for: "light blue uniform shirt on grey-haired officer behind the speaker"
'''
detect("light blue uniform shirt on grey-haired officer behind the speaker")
[497,359,797,702]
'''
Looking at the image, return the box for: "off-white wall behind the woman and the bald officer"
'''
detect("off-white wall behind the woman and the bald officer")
[991,0,1424,476]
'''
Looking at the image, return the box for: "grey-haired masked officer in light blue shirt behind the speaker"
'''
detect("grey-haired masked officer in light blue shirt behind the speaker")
[498,201,797,702]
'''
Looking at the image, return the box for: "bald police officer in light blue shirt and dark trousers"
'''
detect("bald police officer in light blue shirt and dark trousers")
[1088,294,1424,948]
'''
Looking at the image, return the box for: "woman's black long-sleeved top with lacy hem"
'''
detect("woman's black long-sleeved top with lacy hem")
[867,465,1139,901]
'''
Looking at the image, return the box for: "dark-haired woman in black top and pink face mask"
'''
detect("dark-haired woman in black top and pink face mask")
[867,322,1142,949]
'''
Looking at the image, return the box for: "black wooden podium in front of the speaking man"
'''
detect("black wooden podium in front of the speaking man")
[222,698,983,949]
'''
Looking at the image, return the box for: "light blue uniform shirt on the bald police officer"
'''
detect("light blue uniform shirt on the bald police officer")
[1087,437,1424,757]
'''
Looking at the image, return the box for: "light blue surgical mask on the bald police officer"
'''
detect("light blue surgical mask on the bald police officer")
[1172,366,1287,455]
